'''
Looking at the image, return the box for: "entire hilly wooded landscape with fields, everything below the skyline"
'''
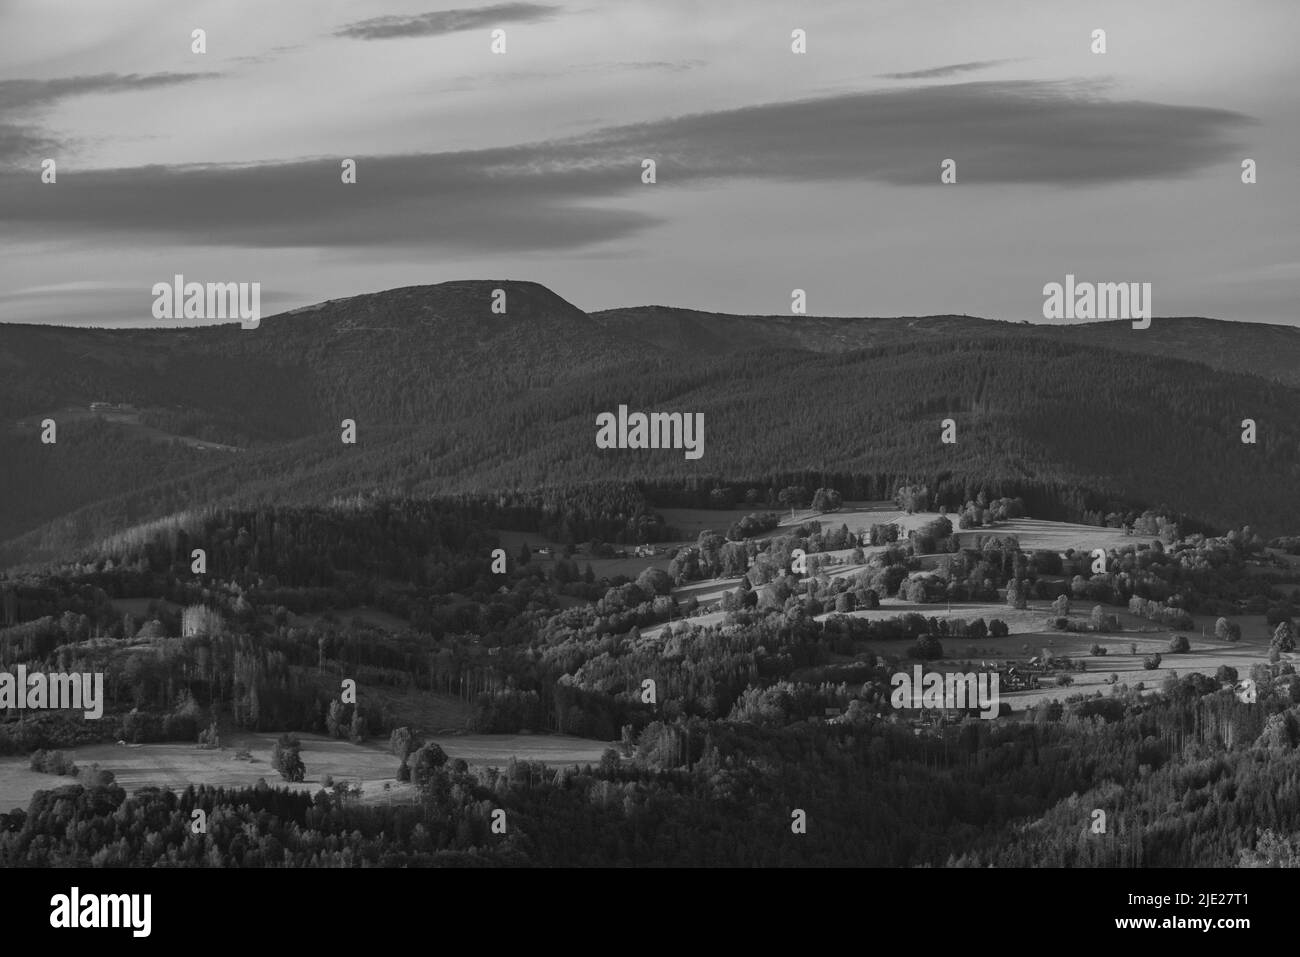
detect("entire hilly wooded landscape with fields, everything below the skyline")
[0,283,1300,867]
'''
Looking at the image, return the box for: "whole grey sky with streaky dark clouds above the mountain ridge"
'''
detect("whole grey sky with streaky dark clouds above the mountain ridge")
[0,0,1300,326]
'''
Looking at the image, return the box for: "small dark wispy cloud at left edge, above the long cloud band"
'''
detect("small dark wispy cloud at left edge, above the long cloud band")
[0,73,221,165]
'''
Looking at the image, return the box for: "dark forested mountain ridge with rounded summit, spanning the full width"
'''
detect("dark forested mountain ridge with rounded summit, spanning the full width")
[0,281,1300,562]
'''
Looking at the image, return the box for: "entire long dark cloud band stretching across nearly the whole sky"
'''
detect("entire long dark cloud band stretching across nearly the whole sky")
[0,81,1255,255]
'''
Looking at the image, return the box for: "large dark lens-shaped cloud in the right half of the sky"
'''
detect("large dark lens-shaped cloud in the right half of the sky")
[530,81,1256,186]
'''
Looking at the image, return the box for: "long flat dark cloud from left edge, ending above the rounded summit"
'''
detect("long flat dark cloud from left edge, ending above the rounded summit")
[0,148,654,252]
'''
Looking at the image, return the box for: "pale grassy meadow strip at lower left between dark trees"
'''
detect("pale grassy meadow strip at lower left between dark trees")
[0,733,612,811]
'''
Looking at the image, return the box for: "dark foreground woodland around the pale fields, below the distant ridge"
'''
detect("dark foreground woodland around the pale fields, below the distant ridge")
[0,501,1300,867]
